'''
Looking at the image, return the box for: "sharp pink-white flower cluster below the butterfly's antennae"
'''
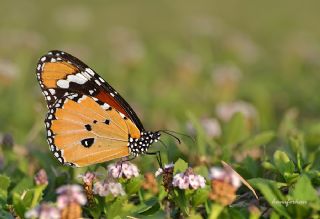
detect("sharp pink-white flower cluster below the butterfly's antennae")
[172,168,206,189]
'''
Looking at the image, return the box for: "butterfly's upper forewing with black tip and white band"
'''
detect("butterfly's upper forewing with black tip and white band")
[37,50,144,131]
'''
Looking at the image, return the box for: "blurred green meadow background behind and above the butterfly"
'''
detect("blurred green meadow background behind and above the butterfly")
[0,0,320,157]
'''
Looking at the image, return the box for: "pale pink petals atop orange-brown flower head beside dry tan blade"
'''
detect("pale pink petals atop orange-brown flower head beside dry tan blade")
[210,167,241,189]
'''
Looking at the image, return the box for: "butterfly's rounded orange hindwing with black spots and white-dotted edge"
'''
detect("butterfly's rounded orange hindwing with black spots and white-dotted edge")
[45,94,139,166]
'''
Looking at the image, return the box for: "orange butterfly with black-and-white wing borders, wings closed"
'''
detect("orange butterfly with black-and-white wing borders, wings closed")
[36,50,161,167]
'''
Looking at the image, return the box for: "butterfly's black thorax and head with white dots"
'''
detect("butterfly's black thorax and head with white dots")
[128,132,161,157]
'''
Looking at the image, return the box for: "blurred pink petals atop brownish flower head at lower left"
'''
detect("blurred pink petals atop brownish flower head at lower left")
[57,185,87,209]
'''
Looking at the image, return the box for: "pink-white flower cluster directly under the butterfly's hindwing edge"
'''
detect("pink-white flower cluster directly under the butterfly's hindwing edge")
[108,161,139,179]
